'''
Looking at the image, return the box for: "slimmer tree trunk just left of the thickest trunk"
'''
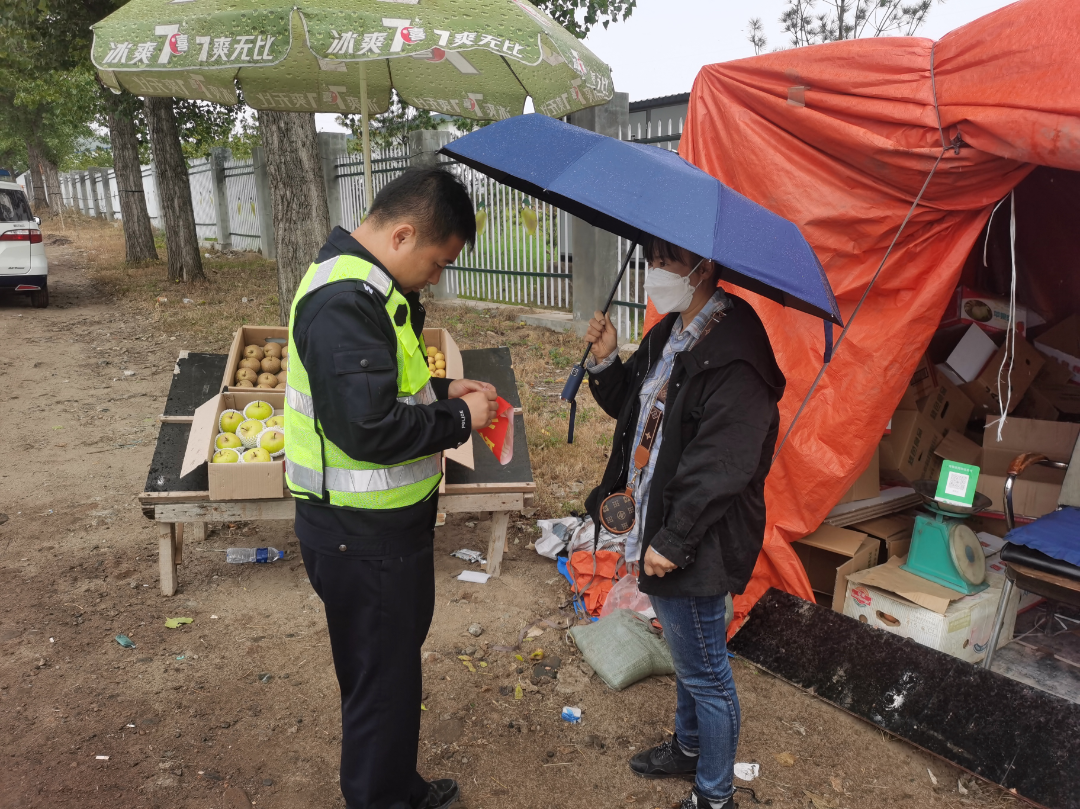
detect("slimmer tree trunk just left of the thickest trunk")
[143,96,206,281]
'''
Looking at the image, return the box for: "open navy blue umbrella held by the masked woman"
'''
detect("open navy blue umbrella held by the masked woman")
[442,114,843,441]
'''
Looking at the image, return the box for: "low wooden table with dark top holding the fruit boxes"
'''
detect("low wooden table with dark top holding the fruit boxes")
[139,348,536,595]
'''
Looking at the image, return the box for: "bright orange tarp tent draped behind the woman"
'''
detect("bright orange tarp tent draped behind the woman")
[647,0,1080,629]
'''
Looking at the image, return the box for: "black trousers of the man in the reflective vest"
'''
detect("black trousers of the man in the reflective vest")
[300,538,435,809]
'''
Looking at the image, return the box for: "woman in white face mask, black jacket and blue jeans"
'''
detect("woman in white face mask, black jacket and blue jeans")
[585,233,784,809]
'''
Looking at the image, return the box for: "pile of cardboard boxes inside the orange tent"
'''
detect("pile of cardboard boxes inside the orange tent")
[816,288,1080,661]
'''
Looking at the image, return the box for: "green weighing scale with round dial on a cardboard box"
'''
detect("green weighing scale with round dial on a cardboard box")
[901,481,993,595]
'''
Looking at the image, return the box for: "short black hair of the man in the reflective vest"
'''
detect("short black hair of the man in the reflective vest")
[367,166,476,247]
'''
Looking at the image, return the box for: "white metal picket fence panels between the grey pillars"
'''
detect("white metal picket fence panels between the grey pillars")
[50,119,683,334]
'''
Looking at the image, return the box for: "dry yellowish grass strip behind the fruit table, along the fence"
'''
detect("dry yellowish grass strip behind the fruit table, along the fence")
[69,217,615,516]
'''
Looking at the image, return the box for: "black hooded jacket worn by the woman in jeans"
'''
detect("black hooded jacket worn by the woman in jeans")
[585,295,785,596]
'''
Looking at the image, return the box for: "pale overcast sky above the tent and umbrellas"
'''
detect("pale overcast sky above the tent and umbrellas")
[318,0,1011,132]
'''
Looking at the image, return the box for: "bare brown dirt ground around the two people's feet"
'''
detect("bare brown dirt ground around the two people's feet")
[0,218,1014,809]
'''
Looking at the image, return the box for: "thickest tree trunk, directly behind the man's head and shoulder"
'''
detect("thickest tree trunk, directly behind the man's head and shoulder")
[259,110,330,324]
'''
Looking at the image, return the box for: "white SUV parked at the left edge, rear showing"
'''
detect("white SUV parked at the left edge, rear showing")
[0,181,49,309]
